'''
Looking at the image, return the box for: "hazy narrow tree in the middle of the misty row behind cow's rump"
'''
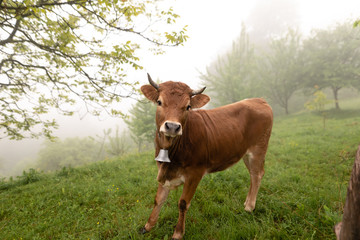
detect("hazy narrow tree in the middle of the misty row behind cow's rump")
[259,29,304,114]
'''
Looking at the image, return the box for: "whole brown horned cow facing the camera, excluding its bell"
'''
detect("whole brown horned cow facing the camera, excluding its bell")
[141,75,273,239]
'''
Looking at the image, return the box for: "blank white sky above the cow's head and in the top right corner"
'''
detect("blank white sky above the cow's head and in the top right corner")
[137,0,360,88]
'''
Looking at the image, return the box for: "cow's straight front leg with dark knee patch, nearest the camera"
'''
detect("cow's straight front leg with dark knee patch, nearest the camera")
[172,174,203,239]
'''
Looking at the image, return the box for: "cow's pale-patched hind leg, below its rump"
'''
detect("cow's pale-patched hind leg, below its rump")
[244,147,266,212]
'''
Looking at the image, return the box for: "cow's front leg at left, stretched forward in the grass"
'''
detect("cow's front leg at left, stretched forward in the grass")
[142,184,170,233]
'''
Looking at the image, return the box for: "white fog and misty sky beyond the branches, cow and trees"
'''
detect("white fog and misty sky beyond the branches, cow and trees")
[0,0,360,176]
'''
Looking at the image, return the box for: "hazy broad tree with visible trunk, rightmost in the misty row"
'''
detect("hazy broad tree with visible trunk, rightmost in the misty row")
[304,22,360,109]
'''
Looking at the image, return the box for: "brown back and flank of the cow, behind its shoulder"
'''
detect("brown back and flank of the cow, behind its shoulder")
[197,98,273,172]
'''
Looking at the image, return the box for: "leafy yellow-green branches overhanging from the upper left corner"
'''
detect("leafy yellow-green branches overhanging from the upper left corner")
[0,0,187,139]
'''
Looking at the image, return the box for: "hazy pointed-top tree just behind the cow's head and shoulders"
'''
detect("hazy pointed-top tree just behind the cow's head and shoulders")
[201,24,257,106]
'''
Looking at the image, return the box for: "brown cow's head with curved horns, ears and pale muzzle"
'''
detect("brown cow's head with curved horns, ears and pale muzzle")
[141,74,210,148]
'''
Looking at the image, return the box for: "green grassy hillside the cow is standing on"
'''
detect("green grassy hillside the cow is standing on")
[0,109,360,239]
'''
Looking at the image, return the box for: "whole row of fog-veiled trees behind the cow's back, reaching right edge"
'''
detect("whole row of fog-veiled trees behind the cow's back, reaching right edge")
[201,21,360,114]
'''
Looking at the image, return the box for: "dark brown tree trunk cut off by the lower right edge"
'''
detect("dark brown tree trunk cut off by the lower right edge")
[335,145,360,240]
